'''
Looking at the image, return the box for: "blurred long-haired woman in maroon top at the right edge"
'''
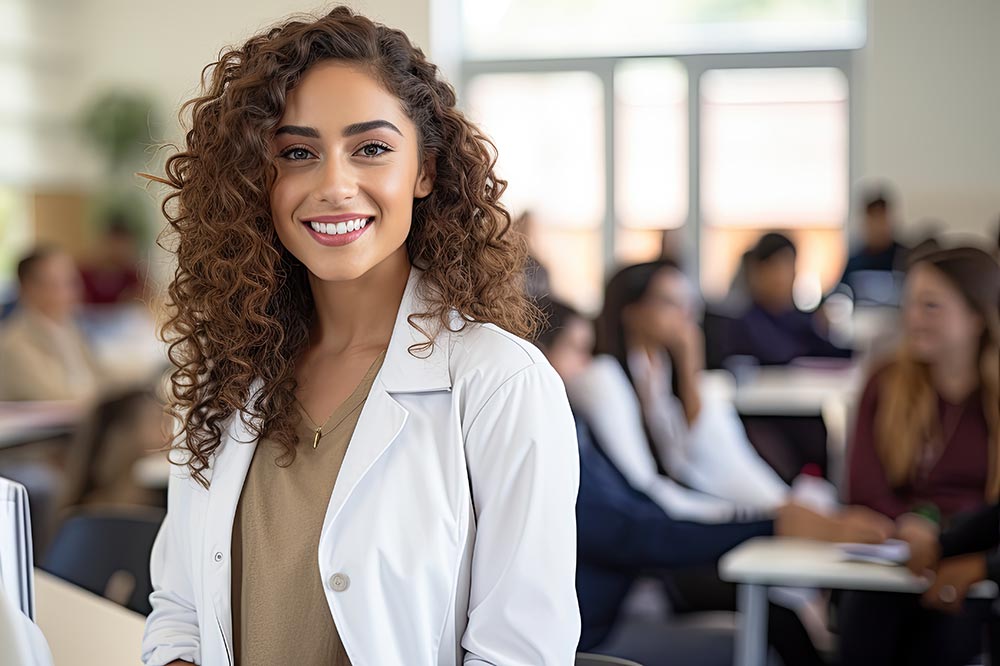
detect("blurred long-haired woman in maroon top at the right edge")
[840,248,1000,666]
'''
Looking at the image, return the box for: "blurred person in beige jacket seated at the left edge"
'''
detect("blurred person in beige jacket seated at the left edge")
[0,247,101,400]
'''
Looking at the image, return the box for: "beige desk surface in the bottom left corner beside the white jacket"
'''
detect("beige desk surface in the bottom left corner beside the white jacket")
[35,569,146,666]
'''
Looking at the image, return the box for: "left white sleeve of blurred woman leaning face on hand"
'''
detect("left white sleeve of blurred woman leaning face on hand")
[572,356,741,523]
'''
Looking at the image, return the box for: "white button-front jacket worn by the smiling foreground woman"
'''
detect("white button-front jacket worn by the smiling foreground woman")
[143,269,580,666]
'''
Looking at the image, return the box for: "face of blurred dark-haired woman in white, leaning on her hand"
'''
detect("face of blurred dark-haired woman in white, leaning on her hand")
[625,268,693,347]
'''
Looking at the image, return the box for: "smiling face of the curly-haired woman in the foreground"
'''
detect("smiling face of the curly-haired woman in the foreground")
[271,61,432,281]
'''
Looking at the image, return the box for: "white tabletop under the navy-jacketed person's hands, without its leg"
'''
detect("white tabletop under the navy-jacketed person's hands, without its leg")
[719,537,997,598]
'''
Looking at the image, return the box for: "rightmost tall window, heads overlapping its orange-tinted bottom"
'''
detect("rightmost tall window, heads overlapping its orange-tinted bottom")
[700,68,848,297]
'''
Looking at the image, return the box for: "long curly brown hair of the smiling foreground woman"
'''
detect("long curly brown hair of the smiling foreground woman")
[155,7,540,486]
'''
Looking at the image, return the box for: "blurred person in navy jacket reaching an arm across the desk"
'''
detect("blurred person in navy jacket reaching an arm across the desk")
[536,294,892,666]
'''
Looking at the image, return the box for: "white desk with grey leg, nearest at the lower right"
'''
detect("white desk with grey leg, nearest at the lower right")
[719,537,997,666]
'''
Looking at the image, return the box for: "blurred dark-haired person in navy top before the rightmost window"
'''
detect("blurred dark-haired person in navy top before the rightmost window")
[725,233,851,365]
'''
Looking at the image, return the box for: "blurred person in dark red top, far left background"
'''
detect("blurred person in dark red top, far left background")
[80,219,142,305]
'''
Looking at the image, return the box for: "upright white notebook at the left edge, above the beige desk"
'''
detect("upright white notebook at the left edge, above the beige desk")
[0,478,35,620]
